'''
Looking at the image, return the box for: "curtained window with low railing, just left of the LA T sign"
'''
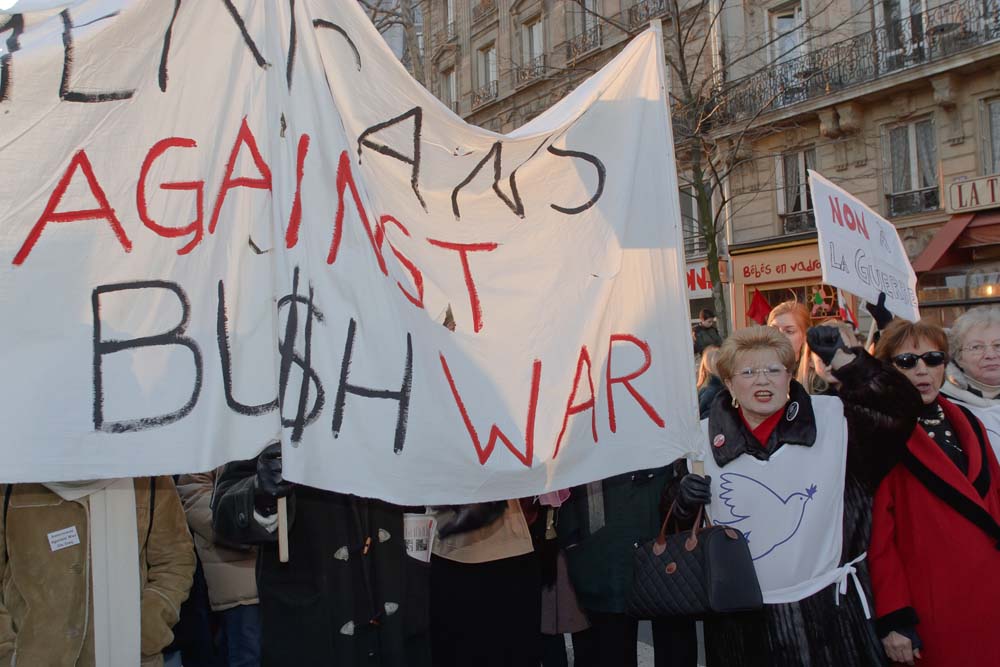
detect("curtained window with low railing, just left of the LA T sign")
[886,118,940,217]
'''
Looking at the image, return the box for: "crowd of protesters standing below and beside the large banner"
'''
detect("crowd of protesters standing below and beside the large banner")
[0,298,1000,667]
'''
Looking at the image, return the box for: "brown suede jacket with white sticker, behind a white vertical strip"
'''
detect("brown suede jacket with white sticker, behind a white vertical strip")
[0,477,195,667]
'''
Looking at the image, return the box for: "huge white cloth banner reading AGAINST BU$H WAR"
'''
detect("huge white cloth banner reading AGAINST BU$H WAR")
[0,0,700,504]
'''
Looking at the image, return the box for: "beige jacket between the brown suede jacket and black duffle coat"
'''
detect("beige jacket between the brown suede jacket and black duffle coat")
[177,471,257,611]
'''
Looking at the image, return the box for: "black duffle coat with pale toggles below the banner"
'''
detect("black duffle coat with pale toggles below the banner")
[212,460,431,667]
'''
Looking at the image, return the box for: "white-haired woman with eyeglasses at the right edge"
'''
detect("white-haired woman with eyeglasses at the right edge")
[941,306,1000,414]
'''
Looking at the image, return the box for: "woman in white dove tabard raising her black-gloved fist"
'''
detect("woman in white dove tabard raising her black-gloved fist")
[665,327,920,667]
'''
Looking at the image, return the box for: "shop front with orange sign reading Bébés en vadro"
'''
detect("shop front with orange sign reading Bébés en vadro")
[729,235,857,328]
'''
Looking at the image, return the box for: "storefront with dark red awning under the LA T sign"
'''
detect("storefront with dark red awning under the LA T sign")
[913,175,1000,327]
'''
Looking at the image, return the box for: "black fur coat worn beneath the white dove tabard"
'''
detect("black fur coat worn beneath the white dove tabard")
[666,348,921,667]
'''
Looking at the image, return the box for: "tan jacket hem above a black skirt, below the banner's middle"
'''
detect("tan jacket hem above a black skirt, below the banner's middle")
[434,500,534,563]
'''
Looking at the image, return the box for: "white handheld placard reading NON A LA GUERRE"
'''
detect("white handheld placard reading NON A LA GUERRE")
[809,169,920,322]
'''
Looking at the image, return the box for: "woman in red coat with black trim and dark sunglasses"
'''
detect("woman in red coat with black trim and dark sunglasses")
[868,320,1000,667]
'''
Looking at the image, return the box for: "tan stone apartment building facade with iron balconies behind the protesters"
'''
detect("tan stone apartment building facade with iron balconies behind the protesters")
[422,0,1000,327]
